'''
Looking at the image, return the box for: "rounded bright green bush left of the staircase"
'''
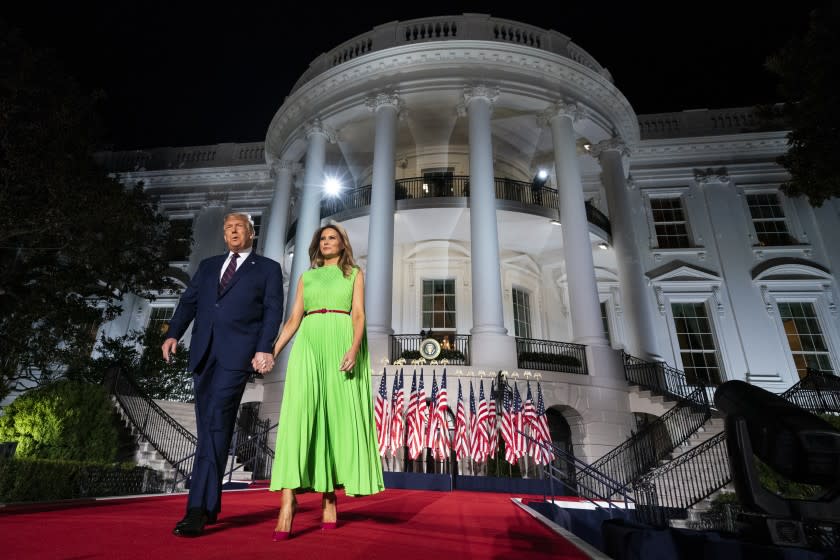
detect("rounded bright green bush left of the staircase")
[0,381,120,462]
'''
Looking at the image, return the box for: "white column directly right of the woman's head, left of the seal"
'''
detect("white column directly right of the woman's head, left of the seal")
[365,93,400,364]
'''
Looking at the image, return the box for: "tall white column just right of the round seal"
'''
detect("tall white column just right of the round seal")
[461,85,516,367]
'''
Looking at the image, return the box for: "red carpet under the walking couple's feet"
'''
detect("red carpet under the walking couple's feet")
[0,490,587,560]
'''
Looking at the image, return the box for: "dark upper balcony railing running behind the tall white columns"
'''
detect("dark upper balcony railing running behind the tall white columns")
[286,175,612,239]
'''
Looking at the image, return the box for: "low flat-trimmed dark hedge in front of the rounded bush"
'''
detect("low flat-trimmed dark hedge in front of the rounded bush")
[0,459,163,503]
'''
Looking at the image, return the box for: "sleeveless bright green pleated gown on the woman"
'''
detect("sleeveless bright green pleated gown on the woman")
[270,265,384,496]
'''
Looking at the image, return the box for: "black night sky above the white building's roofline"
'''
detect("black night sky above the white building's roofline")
[0,0,818,149]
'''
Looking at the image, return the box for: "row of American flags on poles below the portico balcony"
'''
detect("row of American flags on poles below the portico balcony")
[374,368,554,465]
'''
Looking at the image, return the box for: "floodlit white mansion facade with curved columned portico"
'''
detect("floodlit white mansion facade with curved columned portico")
[97,14,840,468]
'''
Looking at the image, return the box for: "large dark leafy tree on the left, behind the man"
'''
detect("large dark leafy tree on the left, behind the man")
[0,22,174,398]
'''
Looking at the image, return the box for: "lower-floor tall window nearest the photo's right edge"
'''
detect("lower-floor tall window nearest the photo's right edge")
[779,301,833,377]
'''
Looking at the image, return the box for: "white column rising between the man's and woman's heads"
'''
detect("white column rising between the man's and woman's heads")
[286,119,335,310]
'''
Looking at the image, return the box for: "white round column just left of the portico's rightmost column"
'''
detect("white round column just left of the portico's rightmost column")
[541,102,608,346]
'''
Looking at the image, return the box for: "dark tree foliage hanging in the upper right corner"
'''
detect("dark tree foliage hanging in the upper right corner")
[767,3,840,206]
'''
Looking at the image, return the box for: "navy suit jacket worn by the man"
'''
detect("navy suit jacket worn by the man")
[167,252,283,372]
